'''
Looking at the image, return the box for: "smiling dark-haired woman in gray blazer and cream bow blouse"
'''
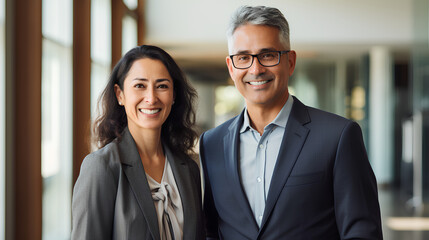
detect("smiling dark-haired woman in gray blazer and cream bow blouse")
[72,45,204,240]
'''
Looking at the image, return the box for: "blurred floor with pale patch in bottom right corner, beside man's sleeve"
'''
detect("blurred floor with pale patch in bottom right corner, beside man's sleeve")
[379,188,429,240]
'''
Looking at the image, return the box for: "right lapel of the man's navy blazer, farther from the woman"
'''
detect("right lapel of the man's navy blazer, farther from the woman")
[261,98,310,229]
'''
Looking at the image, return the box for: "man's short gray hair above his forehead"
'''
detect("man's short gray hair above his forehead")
[227,6,290,54]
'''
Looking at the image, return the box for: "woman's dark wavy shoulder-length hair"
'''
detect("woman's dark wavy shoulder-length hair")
[93,45,198,156]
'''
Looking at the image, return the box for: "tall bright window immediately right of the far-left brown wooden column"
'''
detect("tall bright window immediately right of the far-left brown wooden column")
[41,0,73,240]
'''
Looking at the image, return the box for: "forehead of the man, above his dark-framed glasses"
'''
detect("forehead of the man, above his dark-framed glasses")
[231,24,284,53]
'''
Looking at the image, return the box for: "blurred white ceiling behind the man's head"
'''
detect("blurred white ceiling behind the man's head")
[145,0,413,61]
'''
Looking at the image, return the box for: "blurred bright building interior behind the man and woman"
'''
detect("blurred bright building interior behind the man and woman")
[0,0,429,240]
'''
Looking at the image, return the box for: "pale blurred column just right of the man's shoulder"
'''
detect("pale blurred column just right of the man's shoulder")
[369,47,394,183]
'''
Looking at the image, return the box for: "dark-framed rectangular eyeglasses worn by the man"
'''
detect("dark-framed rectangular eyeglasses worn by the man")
[229,50,291,69]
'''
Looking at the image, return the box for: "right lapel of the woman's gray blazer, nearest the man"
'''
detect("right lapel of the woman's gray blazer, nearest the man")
[164,145,197,239]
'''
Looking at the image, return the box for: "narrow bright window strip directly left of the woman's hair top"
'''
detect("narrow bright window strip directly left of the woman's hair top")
[91,0,112,119]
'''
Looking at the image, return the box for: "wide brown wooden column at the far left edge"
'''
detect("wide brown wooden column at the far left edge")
[10,0,42,240]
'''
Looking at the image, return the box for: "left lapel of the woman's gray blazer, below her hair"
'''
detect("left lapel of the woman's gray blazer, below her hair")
[119,128,160,240]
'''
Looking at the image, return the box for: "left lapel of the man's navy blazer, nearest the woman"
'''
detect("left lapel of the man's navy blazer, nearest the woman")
[223,111,259,229]
